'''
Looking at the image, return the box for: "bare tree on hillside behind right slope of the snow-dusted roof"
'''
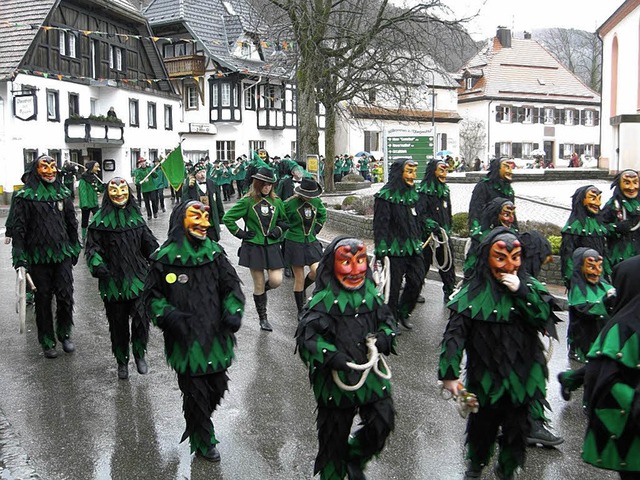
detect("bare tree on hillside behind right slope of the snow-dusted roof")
[535,28,602,92]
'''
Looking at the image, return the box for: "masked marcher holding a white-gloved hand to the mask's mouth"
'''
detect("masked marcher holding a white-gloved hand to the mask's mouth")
[438,227,553,479]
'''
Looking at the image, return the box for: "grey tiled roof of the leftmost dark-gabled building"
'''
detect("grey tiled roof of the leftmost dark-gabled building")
[0,0,150,80]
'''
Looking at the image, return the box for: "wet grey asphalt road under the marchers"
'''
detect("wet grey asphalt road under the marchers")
[0,192,617,480]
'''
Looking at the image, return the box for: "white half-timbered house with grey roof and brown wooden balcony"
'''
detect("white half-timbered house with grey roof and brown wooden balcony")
[144,0,324,160]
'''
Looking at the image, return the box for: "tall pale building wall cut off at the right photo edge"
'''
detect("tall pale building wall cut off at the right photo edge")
[597,0,640,173]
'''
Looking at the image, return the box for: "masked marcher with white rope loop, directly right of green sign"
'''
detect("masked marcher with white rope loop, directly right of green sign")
[416,160,456,302]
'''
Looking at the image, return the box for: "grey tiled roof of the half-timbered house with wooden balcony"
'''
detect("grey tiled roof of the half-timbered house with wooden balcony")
[144,0,292,77]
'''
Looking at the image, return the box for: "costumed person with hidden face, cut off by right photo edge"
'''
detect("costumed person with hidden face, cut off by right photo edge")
[582,256,640,480]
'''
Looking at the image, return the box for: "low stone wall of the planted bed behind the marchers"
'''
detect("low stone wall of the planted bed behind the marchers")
[327,208,562,285]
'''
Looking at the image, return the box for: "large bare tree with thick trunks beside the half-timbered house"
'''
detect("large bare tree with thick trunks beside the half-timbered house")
[250,0,476,191]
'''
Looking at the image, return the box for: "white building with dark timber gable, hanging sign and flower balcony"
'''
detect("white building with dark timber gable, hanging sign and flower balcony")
[0,0,181,193]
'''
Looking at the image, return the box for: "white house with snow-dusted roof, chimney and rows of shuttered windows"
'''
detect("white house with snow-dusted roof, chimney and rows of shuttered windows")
[458,27,600,166]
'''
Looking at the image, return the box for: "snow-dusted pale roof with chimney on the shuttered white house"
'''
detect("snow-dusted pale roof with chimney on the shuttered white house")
[458,37,600,104]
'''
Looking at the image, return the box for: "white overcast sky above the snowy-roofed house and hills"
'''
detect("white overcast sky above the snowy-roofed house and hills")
[442,0,624,40]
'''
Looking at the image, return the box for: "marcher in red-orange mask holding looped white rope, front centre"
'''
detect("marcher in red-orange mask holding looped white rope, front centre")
[296,236,396,480]
